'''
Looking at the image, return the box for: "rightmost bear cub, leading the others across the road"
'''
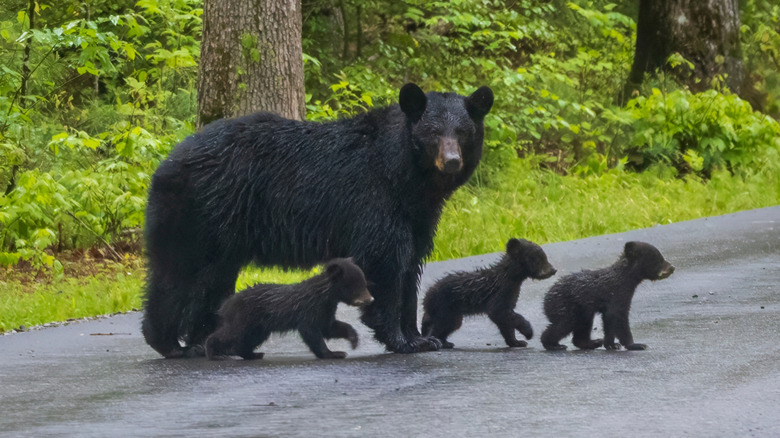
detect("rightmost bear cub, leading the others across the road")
[542,242,674,350]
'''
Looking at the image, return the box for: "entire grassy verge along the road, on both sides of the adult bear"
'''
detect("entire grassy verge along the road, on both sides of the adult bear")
[0,160,780,332]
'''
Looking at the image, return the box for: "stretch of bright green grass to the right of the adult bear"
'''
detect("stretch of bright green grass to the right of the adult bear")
[431,160,780,260]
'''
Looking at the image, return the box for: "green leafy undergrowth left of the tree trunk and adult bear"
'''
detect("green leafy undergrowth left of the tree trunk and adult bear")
[0,0,201,273]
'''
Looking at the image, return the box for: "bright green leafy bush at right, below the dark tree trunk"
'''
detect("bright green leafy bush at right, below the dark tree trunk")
[605,88,780,177]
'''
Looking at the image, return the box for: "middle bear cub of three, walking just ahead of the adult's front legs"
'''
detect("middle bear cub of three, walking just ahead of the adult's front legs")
[422,239,556,348]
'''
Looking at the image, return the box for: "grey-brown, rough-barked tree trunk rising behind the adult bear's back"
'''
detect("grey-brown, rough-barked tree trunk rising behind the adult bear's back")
[198,0,306,127]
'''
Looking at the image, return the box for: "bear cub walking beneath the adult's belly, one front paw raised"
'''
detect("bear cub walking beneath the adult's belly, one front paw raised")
[205,259,374,359]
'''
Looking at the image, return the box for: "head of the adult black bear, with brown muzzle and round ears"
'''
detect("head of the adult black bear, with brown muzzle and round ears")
[398,83,493,184]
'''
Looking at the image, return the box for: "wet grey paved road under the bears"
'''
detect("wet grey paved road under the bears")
[0,206,780,437]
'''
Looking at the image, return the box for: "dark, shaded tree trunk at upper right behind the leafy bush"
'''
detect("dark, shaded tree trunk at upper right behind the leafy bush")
[626,0,743,97]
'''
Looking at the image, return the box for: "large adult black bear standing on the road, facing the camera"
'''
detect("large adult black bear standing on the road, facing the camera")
[142,84,493,357]
